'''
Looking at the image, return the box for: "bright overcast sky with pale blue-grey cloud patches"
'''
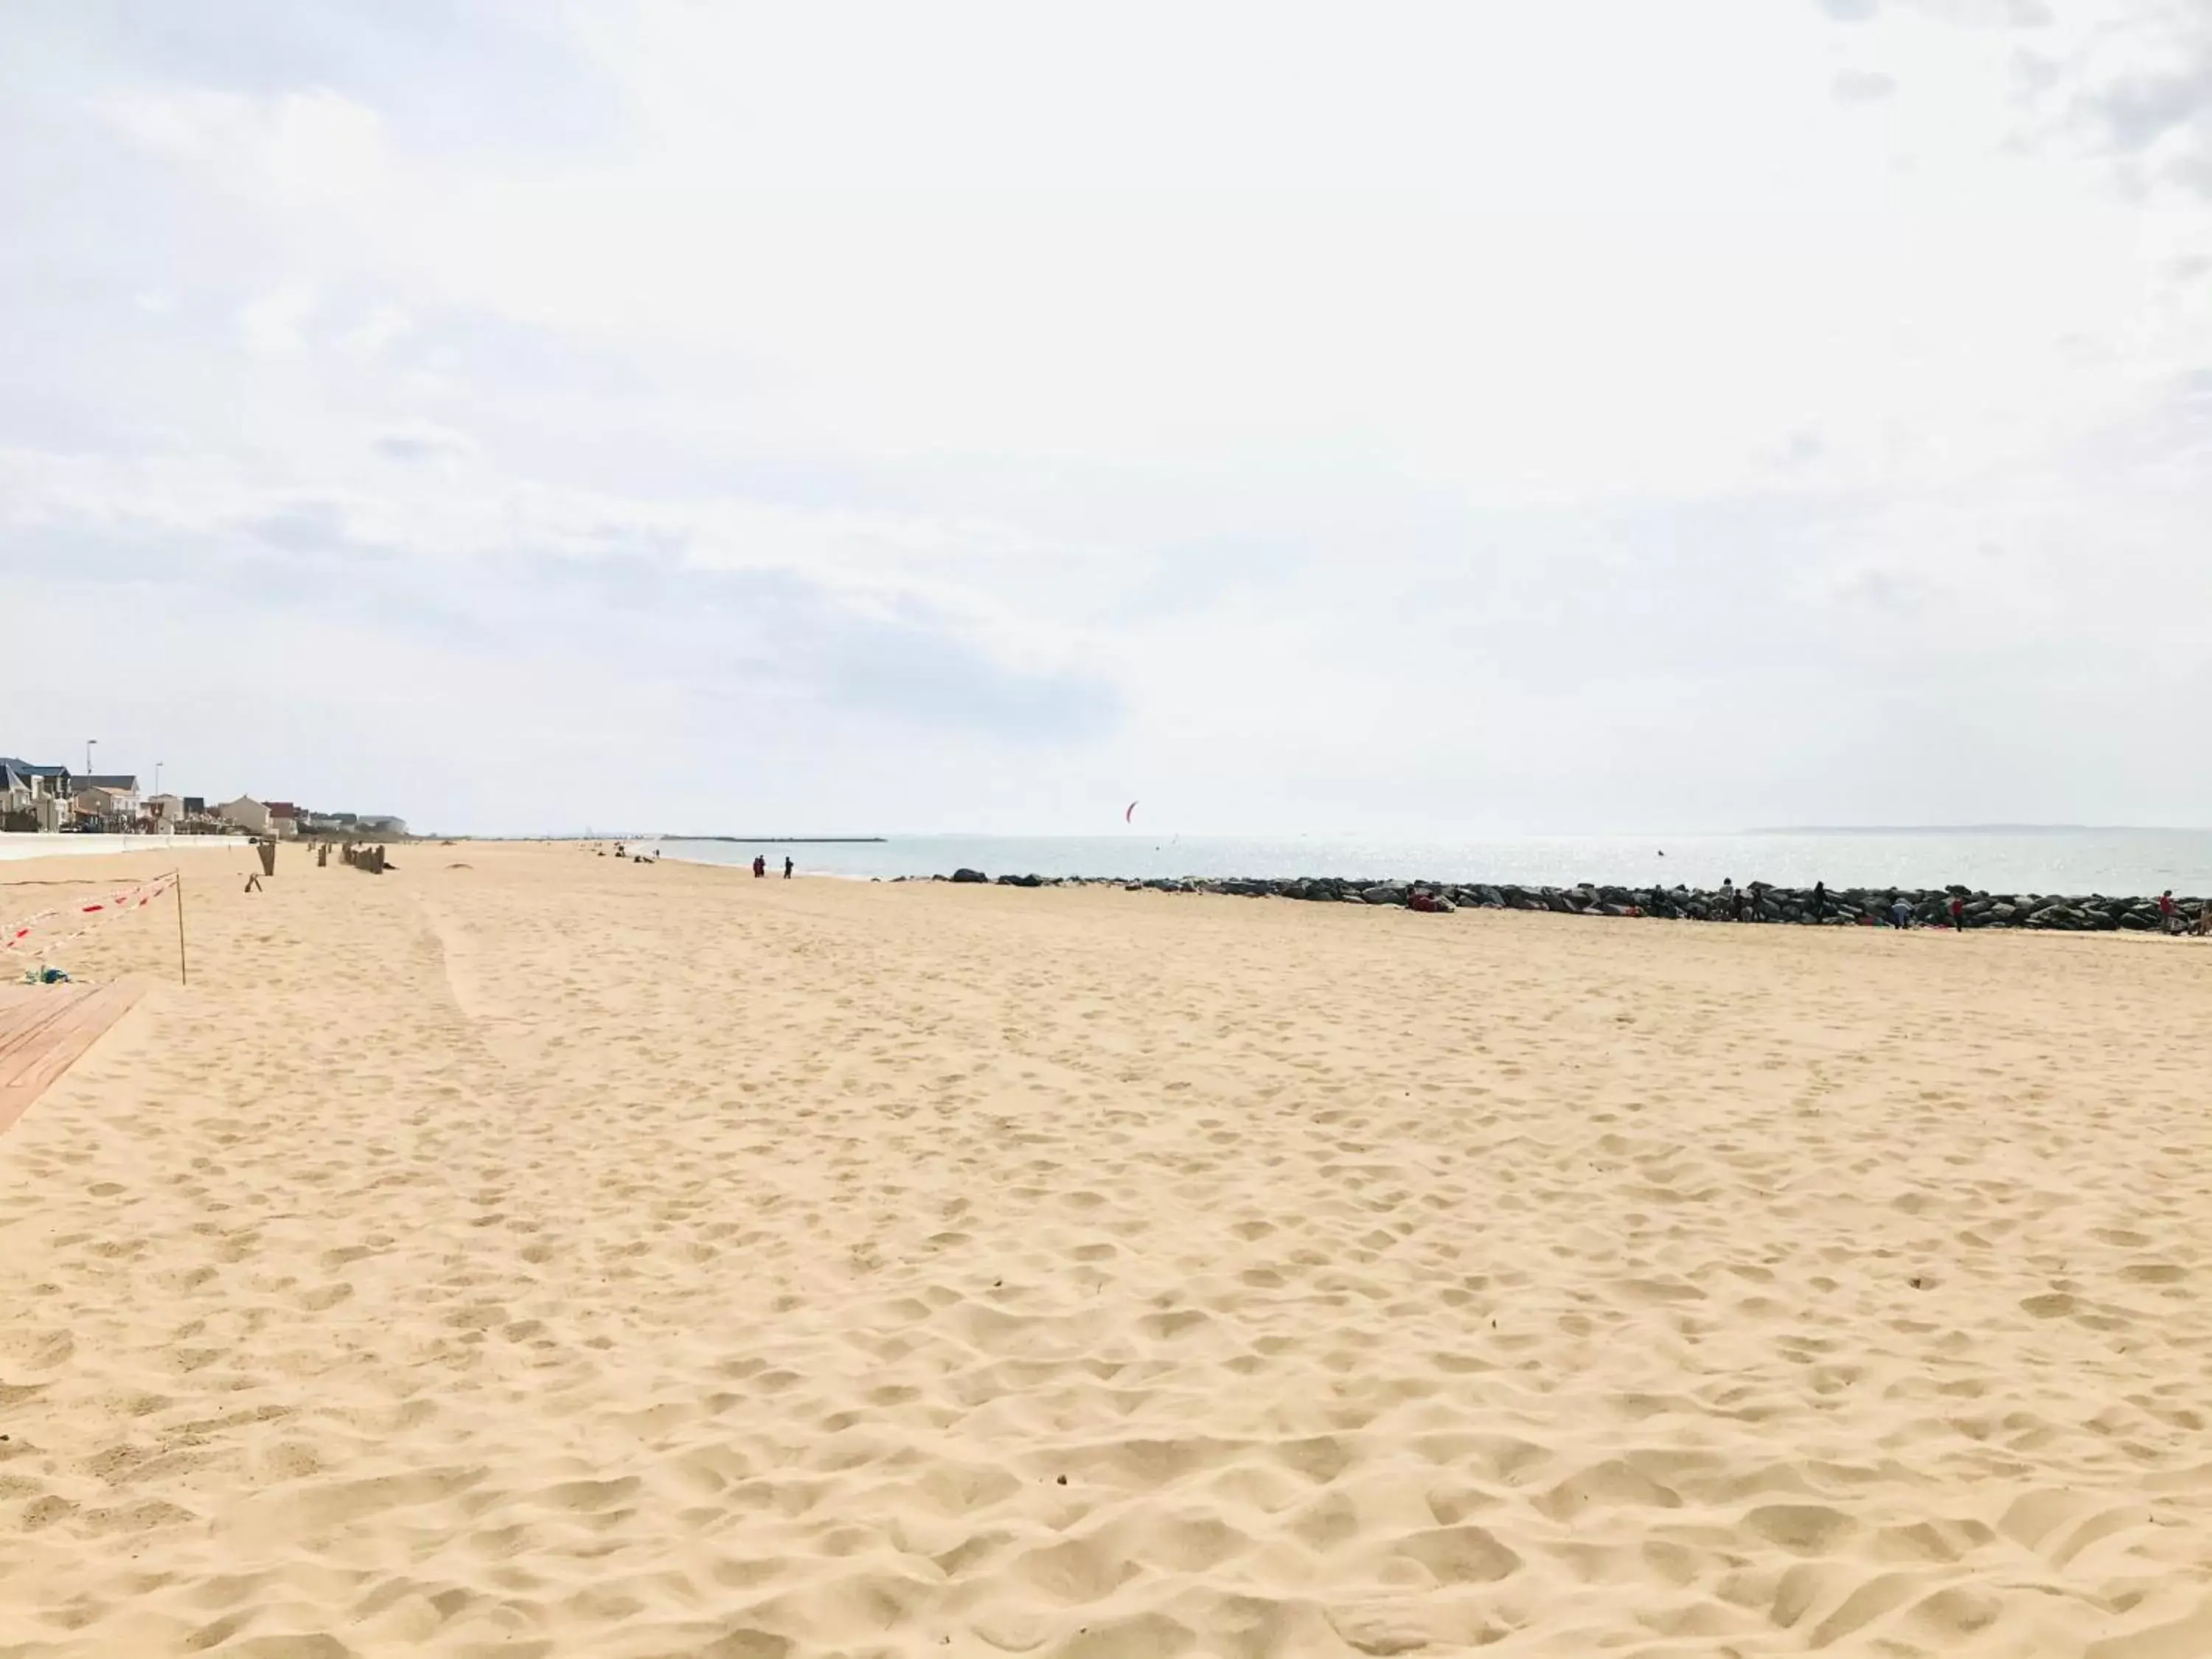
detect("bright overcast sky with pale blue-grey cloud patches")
[0,0,2212,834]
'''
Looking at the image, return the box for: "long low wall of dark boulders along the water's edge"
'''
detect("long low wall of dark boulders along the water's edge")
[916,869,2205,933]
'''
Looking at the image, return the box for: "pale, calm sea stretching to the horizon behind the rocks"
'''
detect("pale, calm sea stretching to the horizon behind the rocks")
[659,830,2212,894]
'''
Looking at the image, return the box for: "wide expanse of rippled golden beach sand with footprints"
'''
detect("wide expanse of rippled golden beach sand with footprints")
[0,845,2212,1659]
